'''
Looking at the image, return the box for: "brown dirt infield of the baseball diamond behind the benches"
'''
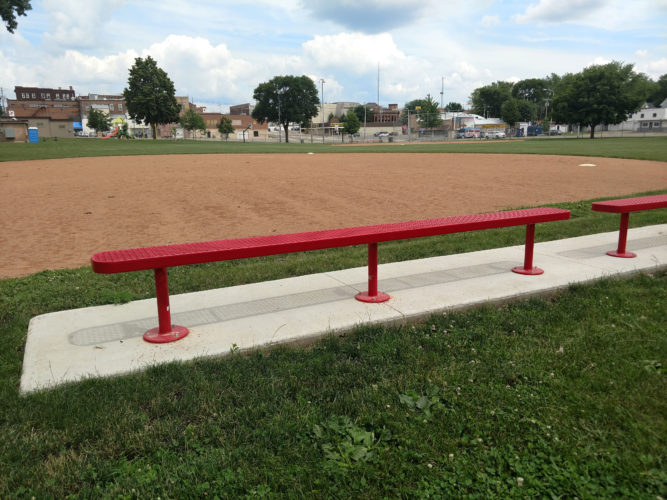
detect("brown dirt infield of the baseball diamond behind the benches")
[0,153,667,278]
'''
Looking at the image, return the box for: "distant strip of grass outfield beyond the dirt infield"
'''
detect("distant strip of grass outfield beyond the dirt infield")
[0,137,667,161]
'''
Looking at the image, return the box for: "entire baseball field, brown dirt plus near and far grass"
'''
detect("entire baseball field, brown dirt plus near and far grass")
[0,138,667,499]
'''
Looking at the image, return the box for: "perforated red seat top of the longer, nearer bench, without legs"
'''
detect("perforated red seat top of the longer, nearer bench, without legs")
[91,208,570,274]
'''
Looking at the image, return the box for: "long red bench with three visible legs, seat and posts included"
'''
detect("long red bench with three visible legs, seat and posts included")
[91,208,570,343]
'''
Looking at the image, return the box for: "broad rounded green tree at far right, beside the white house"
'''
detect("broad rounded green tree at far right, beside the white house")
[553,61,647,139]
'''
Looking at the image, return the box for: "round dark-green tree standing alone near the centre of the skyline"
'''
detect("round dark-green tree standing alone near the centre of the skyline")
[252,75,320,142]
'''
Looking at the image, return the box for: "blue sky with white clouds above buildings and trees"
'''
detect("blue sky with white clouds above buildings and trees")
[0,0,667,112]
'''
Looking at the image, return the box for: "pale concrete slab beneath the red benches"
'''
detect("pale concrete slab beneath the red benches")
[20,224,667,393]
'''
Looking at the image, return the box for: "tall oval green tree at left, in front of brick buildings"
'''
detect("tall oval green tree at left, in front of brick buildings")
[123,56,179,139]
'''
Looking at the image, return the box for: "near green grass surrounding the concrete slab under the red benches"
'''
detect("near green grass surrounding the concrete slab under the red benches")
[0,191,667,499]
